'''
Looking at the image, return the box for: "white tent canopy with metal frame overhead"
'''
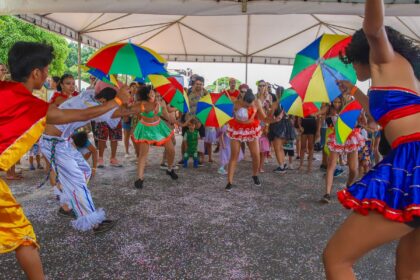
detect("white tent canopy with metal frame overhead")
[0,0,420,64]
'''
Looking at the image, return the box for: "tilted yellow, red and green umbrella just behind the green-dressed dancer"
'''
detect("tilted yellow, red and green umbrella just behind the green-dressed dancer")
[147,75,190,113]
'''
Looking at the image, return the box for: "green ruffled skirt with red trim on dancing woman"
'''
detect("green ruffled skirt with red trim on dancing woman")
[133,119,174,146]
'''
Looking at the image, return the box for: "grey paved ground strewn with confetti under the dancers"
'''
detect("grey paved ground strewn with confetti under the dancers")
[0,135,395,280]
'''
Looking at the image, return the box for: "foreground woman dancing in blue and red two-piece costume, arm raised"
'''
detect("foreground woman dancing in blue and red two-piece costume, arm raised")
[323,0,420,279]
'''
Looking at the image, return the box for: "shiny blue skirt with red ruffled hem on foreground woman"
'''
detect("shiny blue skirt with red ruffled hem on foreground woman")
[337,133,420,222]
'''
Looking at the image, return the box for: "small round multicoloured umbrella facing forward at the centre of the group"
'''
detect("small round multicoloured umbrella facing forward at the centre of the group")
[196,93,233,127]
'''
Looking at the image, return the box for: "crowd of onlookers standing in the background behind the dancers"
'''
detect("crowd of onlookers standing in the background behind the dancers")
[0,64,380,202]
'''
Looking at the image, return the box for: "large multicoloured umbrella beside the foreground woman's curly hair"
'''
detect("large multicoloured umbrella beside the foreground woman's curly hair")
[290,34,356,102]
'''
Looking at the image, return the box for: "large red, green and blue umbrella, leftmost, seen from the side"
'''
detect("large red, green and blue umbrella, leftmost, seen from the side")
[86,43,166,78]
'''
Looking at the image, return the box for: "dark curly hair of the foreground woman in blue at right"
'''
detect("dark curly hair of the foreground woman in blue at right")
[340,26,420,80]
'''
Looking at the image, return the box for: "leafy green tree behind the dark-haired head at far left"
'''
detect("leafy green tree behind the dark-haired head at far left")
[0,16,69,76]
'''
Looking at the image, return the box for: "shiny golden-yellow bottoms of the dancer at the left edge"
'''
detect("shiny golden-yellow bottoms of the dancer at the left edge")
[0,179,38,254]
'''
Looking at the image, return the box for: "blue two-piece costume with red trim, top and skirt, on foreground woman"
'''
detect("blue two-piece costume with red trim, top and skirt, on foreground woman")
[338,88,420,223]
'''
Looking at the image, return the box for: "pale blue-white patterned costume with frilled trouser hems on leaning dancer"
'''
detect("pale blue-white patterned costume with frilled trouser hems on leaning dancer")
[39,90,120,231]
